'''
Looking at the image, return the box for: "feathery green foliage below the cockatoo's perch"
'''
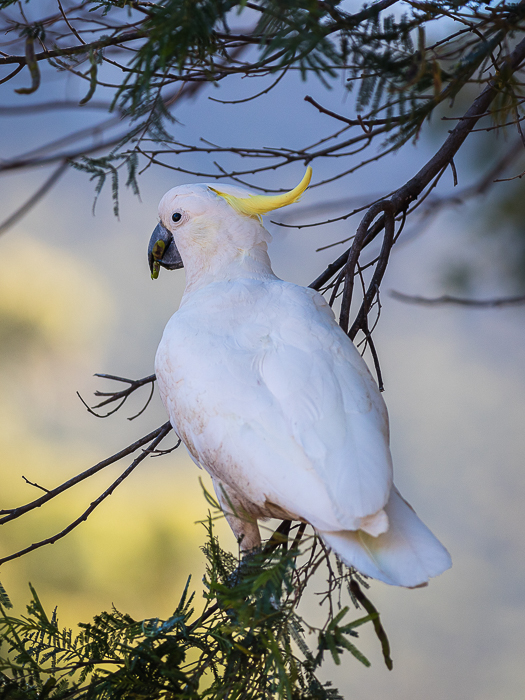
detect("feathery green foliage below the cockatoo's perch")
[0,519,384,700]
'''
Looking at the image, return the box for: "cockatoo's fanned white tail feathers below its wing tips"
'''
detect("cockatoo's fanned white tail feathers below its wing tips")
[319,486,452,588]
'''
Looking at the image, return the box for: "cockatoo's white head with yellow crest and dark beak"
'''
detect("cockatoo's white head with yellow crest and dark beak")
[148,167,312,279]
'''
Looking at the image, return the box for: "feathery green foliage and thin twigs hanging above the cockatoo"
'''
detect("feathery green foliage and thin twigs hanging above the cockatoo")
[0,0,525,213]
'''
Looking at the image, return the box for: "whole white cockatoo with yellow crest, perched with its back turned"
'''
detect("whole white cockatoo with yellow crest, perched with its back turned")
[149,168,451,587]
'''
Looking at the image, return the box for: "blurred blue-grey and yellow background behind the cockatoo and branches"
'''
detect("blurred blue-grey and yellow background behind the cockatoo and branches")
[0,4,525,700]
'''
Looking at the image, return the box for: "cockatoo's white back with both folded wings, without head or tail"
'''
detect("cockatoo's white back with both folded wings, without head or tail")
[156,280,392,530]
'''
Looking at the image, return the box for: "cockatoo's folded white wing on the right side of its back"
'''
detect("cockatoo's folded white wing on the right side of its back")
[254,285,392,527]
